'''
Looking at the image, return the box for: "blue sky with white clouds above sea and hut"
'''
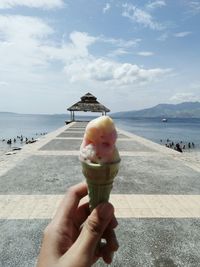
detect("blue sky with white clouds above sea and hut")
[0,0,200,113]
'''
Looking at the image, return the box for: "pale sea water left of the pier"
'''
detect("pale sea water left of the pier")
[0,113,69,154]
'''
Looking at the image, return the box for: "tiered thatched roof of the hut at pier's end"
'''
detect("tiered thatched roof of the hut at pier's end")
[67,93,110,112]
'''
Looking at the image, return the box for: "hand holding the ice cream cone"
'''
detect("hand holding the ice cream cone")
[37,183,118,267]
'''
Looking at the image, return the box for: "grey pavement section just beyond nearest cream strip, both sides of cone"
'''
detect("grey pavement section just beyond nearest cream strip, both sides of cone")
[0,155,200,195]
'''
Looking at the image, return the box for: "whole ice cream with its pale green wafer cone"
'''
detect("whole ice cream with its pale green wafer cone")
[79,116,120,213]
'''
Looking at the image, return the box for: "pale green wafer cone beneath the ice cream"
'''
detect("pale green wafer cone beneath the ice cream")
[81,159,120,211]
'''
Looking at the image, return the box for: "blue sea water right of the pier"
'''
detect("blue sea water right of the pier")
[115,118,200,149]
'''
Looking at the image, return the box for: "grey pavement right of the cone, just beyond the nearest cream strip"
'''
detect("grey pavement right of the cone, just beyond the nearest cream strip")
[114,153,200,195]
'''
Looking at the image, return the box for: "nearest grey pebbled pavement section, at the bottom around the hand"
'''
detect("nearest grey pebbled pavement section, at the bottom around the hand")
[0,218,200,267]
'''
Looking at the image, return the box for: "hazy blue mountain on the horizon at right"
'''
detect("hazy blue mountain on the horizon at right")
[112,102,200,118]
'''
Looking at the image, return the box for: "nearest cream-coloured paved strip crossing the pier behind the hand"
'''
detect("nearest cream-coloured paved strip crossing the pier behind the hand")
[0,194,200,220]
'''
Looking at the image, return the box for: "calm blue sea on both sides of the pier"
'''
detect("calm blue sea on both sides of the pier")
[0,113,200,150]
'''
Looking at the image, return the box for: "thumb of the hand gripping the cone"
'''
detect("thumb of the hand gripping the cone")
[78,203,114,255]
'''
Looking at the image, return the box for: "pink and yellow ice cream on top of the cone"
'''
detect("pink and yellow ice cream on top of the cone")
[80,116,120,164]
